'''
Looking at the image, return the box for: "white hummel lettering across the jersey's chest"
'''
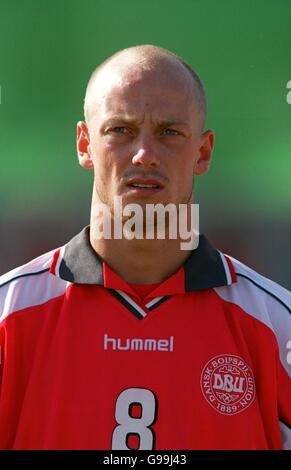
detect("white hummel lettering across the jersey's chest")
[104,334,174,352]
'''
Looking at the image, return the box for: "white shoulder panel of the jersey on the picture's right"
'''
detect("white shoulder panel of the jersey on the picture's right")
[215,258,291,376]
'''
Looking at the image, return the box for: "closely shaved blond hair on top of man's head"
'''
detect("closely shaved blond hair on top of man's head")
[84,44,207,129]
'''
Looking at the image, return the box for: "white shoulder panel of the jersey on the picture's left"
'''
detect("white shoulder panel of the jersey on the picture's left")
[0,250,67,322]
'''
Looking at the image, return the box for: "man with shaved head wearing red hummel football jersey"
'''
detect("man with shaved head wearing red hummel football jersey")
[0,46,291,449]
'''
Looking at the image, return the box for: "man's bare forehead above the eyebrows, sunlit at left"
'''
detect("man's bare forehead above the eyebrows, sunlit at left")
[90,64,200,123]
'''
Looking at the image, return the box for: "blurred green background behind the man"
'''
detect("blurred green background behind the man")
[0,0,291,288]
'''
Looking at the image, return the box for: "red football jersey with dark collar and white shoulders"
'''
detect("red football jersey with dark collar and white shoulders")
[0,228,291,450]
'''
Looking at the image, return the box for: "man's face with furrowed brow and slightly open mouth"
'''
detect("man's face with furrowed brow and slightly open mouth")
[79,60,213,213]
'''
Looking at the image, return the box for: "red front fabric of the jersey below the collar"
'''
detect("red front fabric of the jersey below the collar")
[0,284,291,450]
